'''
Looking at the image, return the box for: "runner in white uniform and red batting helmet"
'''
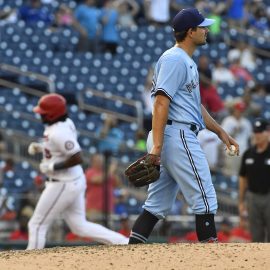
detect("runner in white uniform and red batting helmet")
[27,94,128,249]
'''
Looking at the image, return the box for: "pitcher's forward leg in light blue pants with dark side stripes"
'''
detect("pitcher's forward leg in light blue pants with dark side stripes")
[163,128,217,242]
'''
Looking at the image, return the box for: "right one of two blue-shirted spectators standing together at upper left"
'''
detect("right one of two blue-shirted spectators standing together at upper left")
[101,1,119,54]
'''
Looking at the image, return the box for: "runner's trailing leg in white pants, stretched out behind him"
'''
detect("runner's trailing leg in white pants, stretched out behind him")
[63,179,128,245]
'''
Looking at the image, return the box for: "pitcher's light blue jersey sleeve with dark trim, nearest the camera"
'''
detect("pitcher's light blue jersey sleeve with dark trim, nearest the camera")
[154,58,186,100]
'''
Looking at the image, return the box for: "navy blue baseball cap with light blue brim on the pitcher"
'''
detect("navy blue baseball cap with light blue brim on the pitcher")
[172,8,215,32]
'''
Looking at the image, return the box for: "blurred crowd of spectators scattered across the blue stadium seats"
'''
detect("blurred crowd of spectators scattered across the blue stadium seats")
[0,0,270,246]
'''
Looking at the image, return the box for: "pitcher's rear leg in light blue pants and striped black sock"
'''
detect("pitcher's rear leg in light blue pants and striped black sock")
[129,167,179,244]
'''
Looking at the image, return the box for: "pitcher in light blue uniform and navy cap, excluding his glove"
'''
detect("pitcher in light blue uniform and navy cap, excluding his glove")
[127,8,239,244]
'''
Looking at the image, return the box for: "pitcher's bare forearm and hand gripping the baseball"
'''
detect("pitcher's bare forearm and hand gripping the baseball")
[201,105,239,155]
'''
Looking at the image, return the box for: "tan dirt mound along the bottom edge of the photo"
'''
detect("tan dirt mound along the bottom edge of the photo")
[0,244,270,270]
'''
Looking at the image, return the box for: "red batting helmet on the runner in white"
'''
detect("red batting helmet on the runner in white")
[33,94,67,122]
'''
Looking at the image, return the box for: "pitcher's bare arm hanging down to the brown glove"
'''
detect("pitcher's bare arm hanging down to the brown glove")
[150,91,170,156]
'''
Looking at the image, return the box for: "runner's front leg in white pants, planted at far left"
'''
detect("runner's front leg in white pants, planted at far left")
[27,183,67,249]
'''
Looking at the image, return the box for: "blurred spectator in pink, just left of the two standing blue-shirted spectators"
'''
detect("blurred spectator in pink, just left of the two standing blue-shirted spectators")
[52,4,87,38]
